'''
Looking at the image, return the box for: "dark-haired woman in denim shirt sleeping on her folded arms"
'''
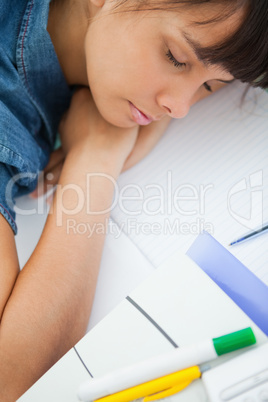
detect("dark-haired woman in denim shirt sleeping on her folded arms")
[0,0,268,401]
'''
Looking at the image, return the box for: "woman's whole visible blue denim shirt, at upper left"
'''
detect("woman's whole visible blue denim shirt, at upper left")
[0,0,71,234]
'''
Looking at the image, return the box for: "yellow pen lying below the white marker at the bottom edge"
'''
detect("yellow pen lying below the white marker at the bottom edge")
[95,366,201,402]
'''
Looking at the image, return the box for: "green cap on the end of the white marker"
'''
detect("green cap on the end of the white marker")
[212,327,256,356]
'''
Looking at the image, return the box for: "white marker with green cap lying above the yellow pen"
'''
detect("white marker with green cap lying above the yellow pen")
[78,328,256,401]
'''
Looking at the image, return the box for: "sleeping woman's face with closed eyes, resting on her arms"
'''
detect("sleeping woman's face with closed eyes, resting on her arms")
[85,0,239,127]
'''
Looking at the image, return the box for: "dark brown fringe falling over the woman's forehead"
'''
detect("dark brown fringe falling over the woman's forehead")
[115,0,268,88]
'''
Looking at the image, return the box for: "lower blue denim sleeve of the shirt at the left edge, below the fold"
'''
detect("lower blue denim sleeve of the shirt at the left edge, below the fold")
[0,101,43,234]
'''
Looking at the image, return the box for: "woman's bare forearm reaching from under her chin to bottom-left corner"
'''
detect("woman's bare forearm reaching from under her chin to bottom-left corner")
[0,90,137,402]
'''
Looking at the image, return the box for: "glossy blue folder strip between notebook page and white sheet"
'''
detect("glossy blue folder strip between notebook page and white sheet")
[187,232,268,336]
